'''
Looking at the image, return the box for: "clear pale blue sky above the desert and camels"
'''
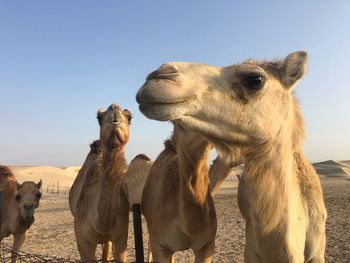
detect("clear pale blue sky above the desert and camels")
[0,0,350,166]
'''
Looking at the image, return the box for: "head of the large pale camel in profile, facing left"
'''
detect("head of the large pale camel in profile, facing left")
[136,51,307,159]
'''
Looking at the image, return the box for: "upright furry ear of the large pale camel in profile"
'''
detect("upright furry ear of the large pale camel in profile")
[281,51,307,89]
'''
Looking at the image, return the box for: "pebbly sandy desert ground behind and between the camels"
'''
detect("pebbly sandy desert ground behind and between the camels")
[4,164,350,262]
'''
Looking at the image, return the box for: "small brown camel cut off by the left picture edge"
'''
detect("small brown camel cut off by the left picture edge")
[0,166,42,262]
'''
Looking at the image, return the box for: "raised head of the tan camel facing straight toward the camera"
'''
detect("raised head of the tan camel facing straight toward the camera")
[97,104,132,149]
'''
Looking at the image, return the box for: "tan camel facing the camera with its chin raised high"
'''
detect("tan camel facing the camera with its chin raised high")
[69,104,131,262]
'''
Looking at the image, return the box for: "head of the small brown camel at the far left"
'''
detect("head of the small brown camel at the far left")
[16,180,42,221]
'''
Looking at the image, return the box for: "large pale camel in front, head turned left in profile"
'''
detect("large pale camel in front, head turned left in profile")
[136,51,327,262]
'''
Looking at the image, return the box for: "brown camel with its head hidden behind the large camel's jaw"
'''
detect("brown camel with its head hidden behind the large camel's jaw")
[141,125,217,263]
